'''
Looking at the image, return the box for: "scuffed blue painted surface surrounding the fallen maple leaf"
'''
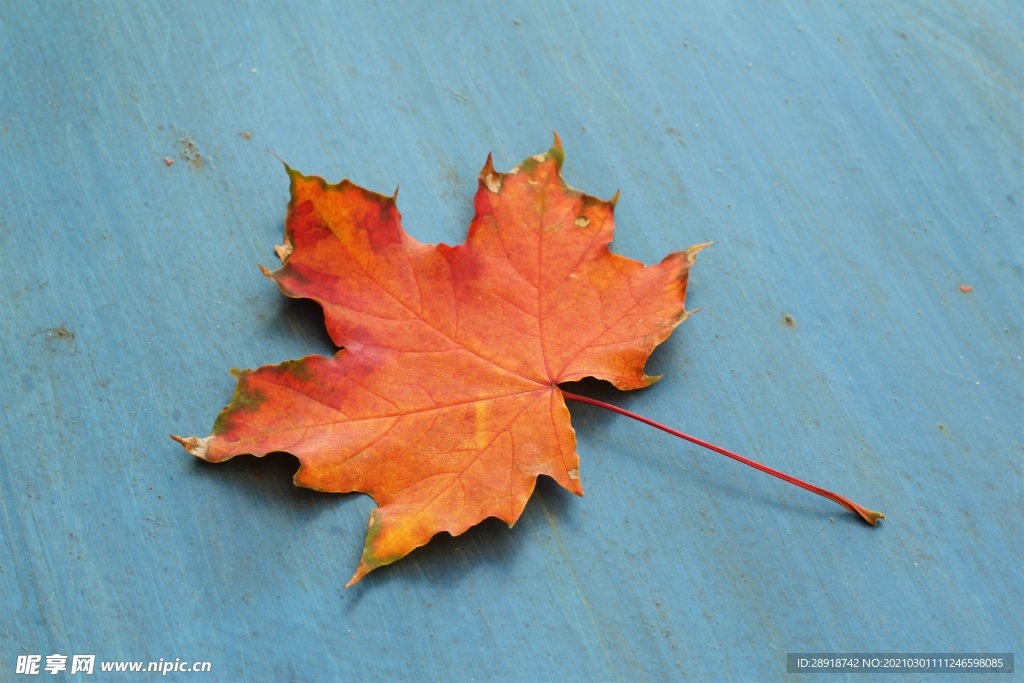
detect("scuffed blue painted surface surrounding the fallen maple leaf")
[0,0,1024,681]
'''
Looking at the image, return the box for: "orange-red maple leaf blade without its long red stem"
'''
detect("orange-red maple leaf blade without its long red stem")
[174,135,705,586]
